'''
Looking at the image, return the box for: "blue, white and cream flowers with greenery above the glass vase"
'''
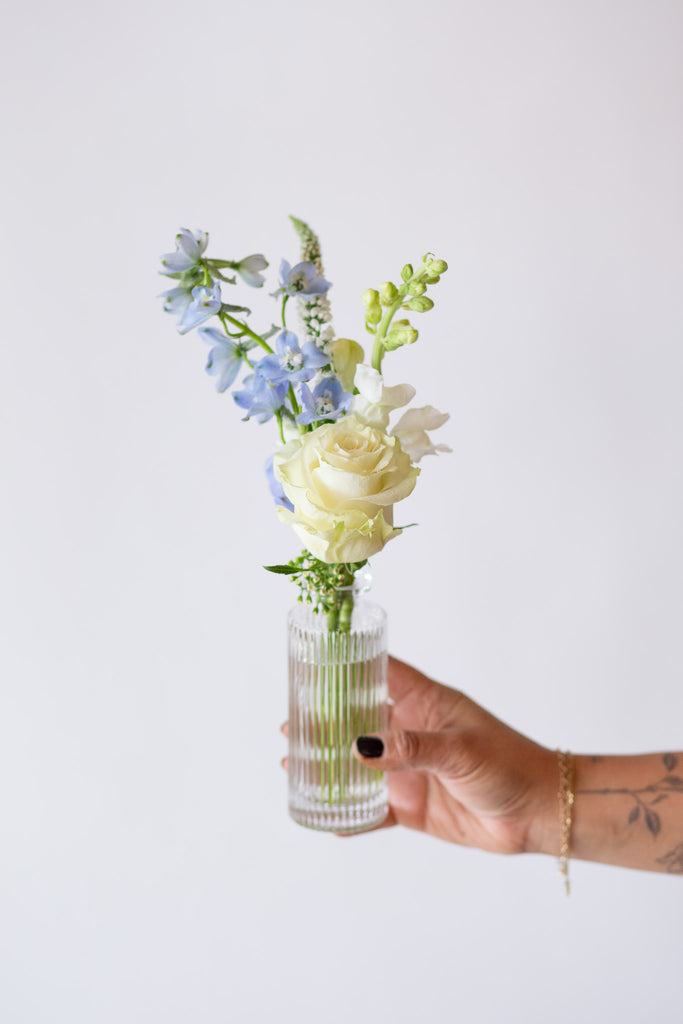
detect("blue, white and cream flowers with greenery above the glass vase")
[161,217,450,630]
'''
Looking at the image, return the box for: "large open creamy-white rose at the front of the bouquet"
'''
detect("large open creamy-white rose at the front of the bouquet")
[274,415,420,562]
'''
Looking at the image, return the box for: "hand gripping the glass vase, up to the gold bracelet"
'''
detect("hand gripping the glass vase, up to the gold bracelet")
[353,657,559,853]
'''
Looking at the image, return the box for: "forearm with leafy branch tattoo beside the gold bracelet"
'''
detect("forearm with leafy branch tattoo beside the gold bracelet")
[542,753,683,874]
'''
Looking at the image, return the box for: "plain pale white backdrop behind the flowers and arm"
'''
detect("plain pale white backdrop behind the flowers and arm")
[0,0,683,1024]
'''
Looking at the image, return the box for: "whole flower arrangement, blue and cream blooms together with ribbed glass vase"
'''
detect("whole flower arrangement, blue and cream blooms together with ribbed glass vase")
[161,217,449,833]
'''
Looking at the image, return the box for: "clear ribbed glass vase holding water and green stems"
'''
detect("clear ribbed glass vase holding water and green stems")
[288,572,388,834]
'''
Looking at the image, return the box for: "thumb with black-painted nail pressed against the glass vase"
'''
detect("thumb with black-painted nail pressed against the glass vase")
[352,729,457,771]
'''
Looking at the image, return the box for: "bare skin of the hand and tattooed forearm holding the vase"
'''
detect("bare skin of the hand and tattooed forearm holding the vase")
[284,657,683,874]
